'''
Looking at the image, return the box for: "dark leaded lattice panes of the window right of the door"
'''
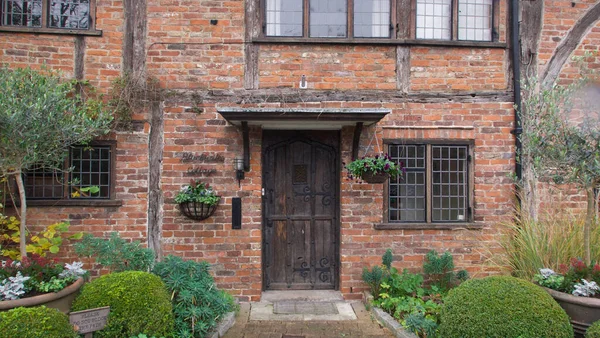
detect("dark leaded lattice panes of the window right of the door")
[387,144,472,223]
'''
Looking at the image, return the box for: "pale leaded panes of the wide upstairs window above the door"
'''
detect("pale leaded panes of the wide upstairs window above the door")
[262,0,499,41]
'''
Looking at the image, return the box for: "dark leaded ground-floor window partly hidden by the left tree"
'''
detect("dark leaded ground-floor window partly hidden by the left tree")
[23,145,114,199]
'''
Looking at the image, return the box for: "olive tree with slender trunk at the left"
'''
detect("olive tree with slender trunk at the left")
[0,66,112,257]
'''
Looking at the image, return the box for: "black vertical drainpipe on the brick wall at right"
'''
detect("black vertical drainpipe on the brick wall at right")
[510,0,523,182]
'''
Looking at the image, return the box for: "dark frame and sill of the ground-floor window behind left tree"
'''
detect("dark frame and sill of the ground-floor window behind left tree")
[20,140,122,206]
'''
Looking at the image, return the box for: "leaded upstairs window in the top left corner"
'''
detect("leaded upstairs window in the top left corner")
[0,0,96,34]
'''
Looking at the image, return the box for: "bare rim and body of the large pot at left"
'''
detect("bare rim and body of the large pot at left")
[0,278,84,314]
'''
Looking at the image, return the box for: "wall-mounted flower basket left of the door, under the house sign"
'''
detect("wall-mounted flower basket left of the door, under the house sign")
[175,180,221,221]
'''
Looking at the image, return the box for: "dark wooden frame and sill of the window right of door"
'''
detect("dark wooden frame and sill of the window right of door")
[375,139,481,229]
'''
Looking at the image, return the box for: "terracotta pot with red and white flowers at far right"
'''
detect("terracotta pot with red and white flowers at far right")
[534,258,600,336]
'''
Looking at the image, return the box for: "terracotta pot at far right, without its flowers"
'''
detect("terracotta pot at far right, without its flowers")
[544,288,600,336]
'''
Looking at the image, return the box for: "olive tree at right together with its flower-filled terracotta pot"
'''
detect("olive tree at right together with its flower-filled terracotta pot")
[520,75,600,333]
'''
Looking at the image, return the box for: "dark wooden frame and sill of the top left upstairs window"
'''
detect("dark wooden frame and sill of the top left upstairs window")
[0,0,102,36]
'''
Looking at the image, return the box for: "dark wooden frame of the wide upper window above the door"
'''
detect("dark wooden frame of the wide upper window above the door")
[253,0,506,47]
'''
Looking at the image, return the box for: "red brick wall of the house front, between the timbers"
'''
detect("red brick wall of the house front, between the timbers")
[0,0,600,301]
